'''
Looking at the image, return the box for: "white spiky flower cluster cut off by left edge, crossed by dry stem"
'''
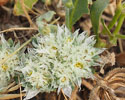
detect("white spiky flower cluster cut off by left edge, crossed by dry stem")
[0,35,20,89]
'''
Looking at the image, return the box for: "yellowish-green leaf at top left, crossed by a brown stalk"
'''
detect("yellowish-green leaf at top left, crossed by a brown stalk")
[13,0,38,16]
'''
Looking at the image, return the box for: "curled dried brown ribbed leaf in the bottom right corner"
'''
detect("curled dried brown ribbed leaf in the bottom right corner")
[89,68,125,100]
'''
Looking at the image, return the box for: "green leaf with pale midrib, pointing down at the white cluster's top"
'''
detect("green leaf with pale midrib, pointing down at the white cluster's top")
[66,0,89,30]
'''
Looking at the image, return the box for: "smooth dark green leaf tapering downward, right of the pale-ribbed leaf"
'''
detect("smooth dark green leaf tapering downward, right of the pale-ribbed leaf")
[90,0,109,36]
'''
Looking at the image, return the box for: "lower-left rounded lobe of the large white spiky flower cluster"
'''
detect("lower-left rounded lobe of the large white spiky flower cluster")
[20,49,51,92]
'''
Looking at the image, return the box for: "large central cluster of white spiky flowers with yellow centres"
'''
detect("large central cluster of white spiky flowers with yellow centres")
[21,26,104,97]
